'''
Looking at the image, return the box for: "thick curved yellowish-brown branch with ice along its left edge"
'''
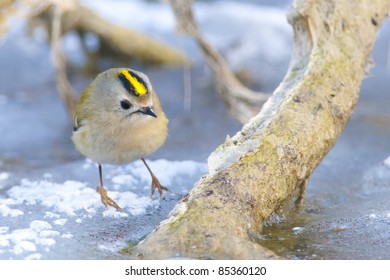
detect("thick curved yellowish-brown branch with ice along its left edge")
[128,0,390,259]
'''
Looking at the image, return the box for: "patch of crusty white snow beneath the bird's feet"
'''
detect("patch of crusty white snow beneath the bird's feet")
[0,160,207,259]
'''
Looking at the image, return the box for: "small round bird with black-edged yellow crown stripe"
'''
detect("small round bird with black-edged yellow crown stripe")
[72,68,169,210]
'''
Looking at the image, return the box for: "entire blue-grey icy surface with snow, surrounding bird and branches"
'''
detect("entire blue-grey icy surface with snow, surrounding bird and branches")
[0,0,390,259]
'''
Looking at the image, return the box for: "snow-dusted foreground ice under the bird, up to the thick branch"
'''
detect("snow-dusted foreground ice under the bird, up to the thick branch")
[0,160,207,259]
